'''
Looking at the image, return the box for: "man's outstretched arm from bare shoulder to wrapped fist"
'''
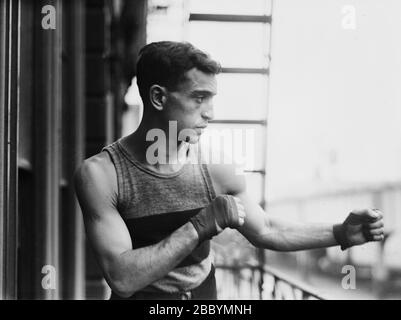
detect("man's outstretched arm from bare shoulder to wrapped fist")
[209,165,384,251]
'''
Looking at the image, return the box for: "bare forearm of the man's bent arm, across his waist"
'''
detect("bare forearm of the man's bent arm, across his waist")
[111,223,198,296]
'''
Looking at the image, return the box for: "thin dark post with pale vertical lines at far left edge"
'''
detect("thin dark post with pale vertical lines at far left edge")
[0,0,20,299]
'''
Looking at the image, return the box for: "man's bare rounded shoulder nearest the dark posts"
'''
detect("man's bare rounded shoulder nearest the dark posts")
[74,151,118,209]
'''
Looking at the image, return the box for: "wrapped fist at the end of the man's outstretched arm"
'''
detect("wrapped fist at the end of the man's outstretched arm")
[333,209,384,250]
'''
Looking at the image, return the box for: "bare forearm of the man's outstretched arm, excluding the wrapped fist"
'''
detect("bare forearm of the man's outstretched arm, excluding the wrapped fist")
[258,217,338,251]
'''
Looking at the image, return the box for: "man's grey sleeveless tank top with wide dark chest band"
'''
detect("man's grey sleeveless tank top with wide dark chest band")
[102,140,216,292]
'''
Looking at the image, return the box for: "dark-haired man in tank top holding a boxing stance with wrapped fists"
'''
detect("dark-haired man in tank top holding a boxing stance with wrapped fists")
[75,41,383,299]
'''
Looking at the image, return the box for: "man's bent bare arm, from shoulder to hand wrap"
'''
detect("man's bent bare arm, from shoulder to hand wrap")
[74,156,199,297]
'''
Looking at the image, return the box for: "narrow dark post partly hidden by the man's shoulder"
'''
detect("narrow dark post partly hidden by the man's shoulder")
[61,0,85,299]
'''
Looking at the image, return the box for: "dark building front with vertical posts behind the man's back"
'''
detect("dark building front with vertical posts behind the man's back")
[0,0,146,299]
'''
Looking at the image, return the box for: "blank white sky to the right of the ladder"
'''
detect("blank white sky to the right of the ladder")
[267,0,401,198]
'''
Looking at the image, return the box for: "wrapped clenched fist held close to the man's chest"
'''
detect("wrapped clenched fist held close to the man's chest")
[190,195,245,242]
